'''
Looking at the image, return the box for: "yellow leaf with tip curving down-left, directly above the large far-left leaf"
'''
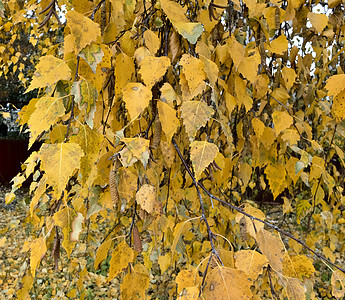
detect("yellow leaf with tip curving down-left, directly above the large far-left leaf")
[28,97,65,148]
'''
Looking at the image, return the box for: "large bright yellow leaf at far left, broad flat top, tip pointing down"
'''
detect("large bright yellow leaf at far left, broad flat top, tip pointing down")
[38,143,84,194]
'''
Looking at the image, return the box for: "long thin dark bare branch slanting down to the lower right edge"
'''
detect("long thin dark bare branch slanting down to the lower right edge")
[172,138,345,274]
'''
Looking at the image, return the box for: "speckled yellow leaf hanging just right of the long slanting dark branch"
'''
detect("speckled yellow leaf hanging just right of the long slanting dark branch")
[190,141,219,180]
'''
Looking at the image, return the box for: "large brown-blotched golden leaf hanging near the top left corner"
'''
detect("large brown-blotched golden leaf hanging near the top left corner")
[66,10,101,54]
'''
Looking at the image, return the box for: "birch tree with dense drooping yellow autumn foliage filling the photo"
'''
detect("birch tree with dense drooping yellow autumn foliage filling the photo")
[1,0,345,299]
